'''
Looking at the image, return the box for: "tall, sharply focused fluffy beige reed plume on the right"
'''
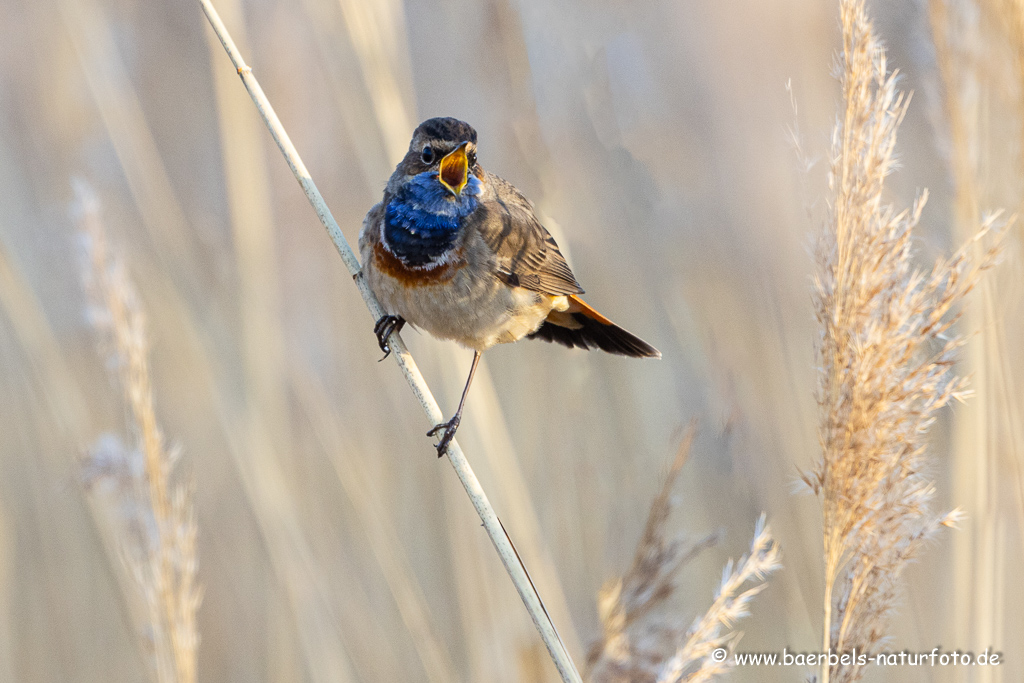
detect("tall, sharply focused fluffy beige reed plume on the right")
[804,0,996,681]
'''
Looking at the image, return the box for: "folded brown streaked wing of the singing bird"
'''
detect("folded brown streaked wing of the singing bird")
[474,173,583,296]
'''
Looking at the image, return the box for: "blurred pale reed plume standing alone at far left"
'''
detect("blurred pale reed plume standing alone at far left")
[75,182,202,683]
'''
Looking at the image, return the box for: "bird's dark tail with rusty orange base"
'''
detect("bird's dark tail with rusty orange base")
[528,295,662,358]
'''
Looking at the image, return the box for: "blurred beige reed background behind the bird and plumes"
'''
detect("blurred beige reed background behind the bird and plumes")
[0,0,1024,683]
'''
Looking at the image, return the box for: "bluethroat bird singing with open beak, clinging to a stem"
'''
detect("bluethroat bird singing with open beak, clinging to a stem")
[359,118,662,457]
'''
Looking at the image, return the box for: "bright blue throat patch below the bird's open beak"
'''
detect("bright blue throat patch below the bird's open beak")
[384,171,481,266]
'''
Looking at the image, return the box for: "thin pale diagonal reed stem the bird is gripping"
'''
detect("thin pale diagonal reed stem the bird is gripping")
[200,0,581,683]
